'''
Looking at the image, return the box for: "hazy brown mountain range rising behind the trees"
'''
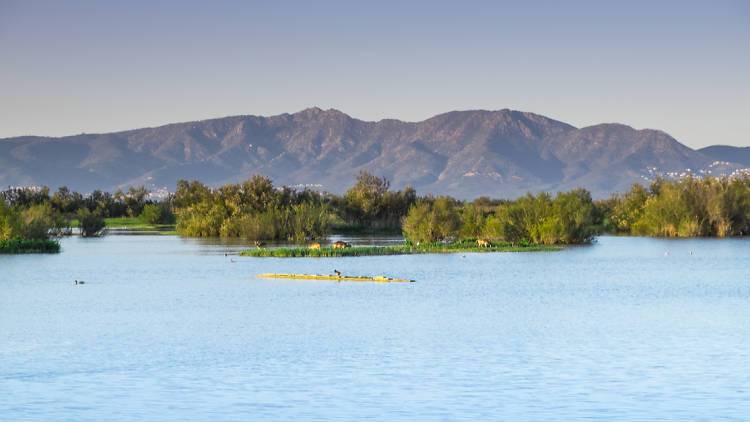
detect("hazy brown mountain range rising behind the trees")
[0,108,750,199]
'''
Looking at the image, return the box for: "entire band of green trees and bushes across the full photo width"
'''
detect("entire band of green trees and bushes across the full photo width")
[0,171,750,251]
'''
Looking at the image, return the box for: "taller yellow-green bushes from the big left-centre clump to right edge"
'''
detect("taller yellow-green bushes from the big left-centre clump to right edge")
[174,172,750,245]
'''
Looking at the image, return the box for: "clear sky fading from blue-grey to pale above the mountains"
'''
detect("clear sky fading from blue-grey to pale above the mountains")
[0,0,750,148]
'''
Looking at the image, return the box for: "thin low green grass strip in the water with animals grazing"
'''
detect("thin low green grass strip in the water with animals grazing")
[240,243,562,258]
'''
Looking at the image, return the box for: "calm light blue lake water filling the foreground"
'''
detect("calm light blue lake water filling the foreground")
[0,236,750,421]
